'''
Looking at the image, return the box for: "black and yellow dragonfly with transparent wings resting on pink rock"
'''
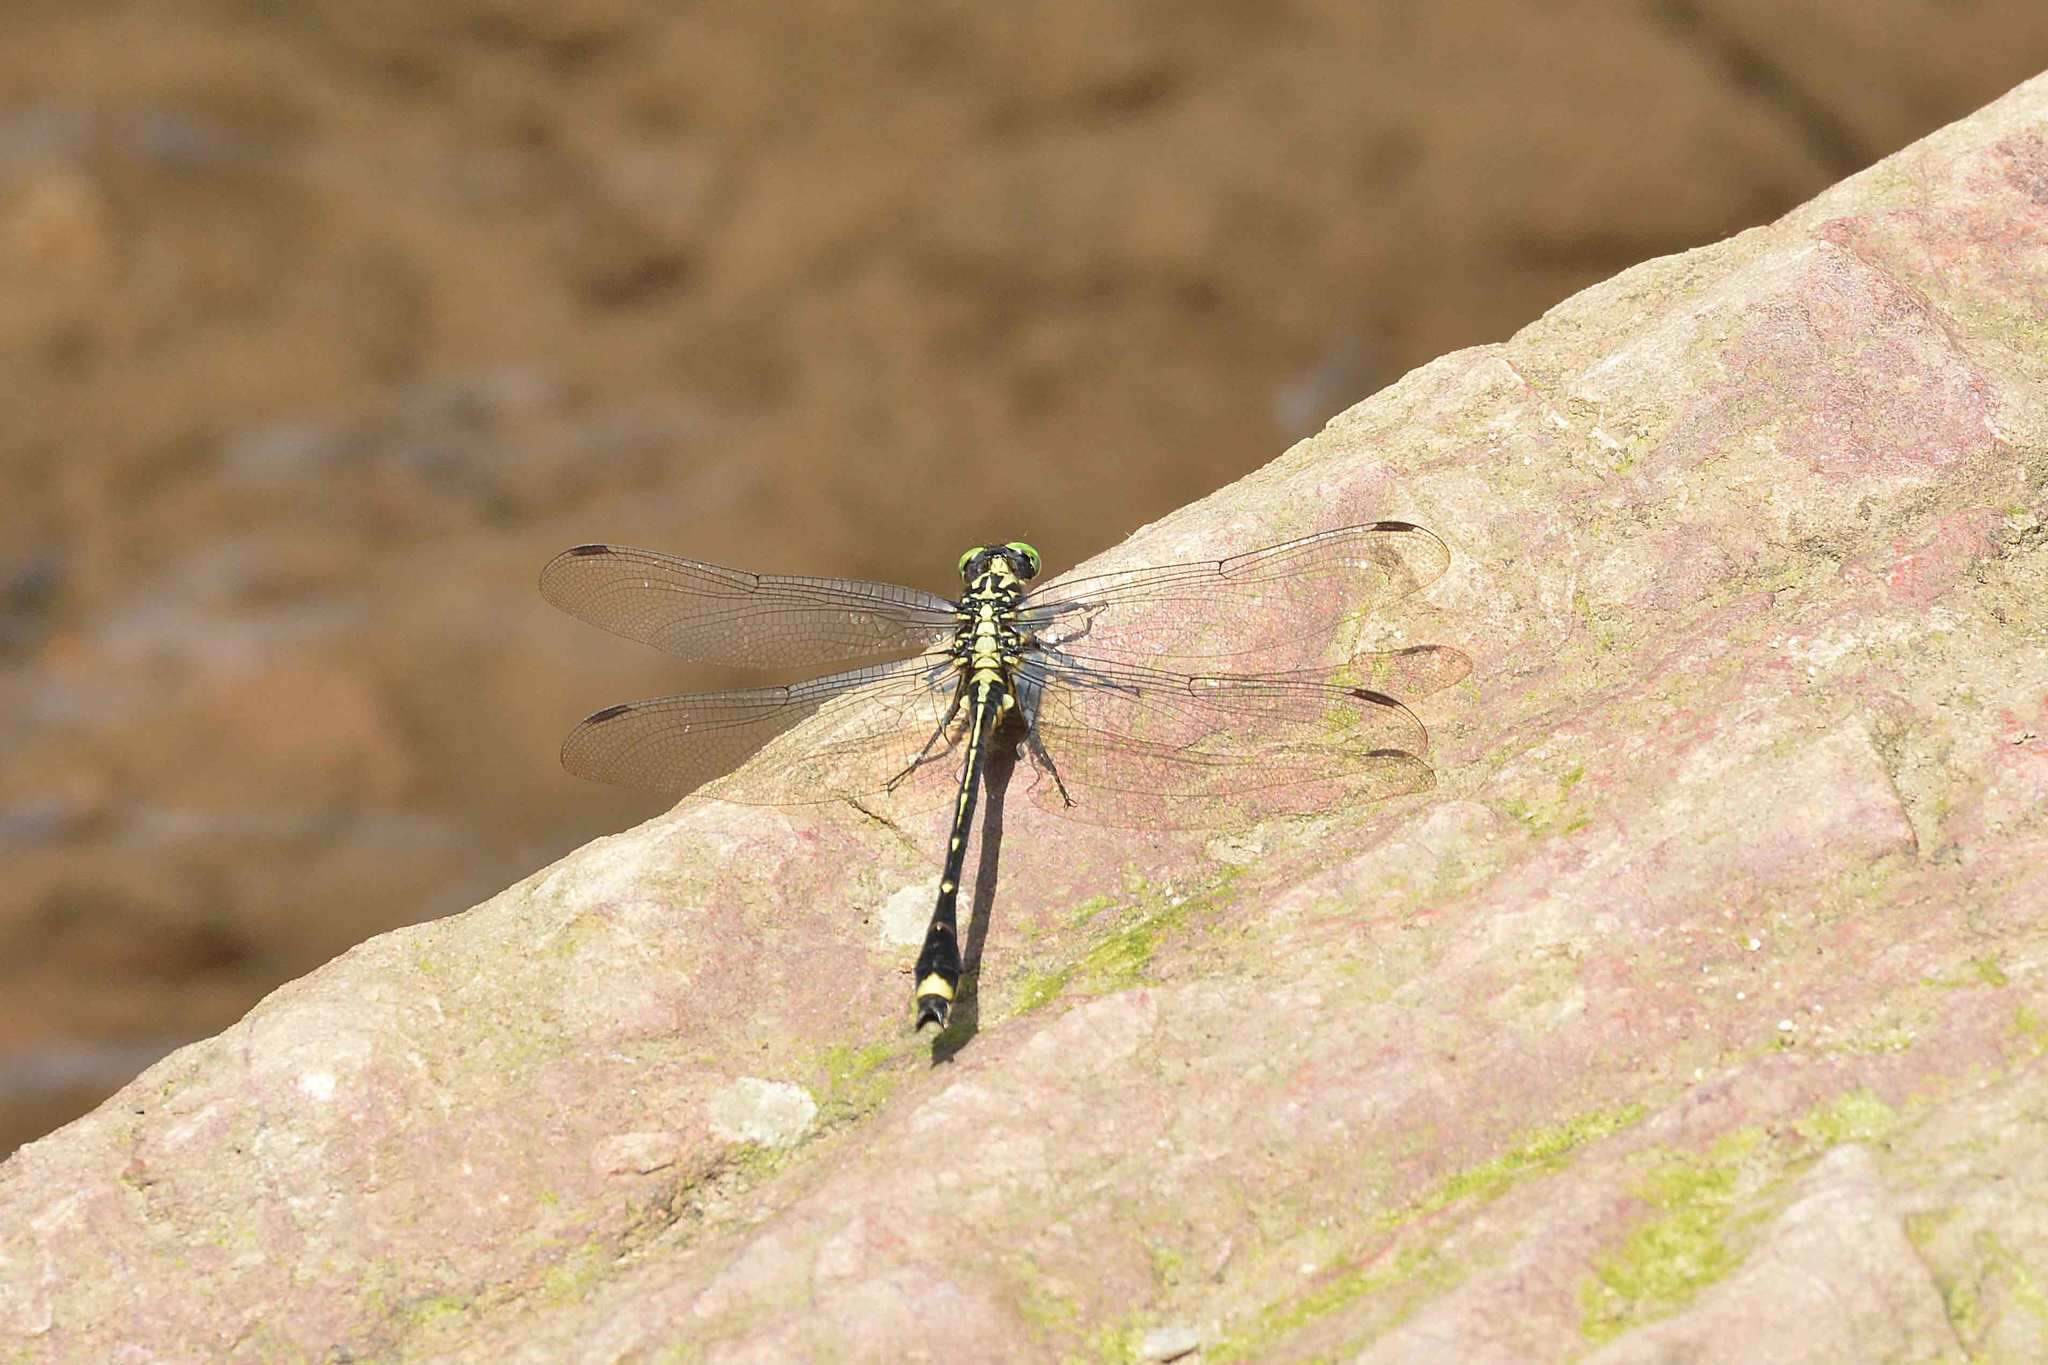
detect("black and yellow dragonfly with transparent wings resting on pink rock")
[541,522,1470,1031]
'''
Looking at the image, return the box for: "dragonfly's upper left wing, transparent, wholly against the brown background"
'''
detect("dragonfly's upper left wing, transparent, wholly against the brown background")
[541,544,958,669]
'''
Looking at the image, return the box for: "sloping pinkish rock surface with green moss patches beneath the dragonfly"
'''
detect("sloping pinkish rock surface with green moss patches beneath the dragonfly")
[0,78,2048,1361]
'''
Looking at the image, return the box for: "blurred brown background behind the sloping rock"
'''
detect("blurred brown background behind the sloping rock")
[0,0,2048,1152]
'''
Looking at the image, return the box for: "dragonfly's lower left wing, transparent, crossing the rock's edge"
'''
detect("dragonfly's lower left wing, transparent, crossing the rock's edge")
[561,653,956,806]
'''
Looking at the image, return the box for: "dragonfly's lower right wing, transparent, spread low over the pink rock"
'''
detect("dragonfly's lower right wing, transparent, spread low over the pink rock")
[1020,653,1434,829]
